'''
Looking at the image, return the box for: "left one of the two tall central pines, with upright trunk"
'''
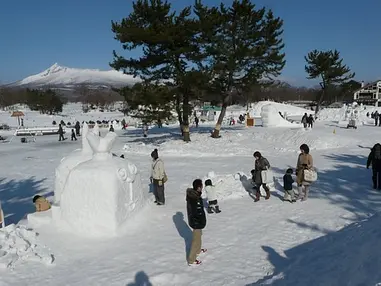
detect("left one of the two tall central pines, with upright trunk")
[110,0,200,141]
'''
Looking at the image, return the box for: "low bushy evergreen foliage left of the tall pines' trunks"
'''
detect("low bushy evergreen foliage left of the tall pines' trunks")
[119,83,174,123]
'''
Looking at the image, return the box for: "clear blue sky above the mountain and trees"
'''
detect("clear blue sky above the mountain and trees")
[0,0,381,85]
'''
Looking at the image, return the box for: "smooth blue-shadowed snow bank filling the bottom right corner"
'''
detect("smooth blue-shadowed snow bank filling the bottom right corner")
[255,213,381,286]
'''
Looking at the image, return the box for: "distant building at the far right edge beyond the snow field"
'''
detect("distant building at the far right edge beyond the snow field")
[353,80,381,107]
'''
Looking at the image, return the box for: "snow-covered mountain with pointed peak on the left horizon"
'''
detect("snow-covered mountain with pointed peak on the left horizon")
[9,63,139,89]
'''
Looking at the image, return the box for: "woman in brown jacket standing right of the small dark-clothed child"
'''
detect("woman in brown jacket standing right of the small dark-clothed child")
[296,144,313,201]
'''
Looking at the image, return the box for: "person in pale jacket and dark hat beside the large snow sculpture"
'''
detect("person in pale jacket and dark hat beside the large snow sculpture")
[150,149,167,206]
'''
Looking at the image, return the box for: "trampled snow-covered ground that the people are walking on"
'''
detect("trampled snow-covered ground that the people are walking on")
[0,100,381,286]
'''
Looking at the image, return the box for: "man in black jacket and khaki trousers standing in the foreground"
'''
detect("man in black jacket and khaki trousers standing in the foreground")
[186,179,206,265]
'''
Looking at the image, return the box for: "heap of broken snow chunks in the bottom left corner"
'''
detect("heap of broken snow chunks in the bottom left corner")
[0,224,54,269]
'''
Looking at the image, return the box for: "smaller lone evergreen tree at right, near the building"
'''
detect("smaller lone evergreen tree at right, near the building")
[304,50,355,114]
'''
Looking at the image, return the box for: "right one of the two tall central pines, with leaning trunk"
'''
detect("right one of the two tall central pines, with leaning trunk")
[195,0,285,138]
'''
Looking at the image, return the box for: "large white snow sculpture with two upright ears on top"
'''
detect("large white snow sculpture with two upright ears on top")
[57,132,148,237]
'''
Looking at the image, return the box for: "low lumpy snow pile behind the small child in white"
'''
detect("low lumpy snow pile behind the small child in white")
[203,172,247,200]
